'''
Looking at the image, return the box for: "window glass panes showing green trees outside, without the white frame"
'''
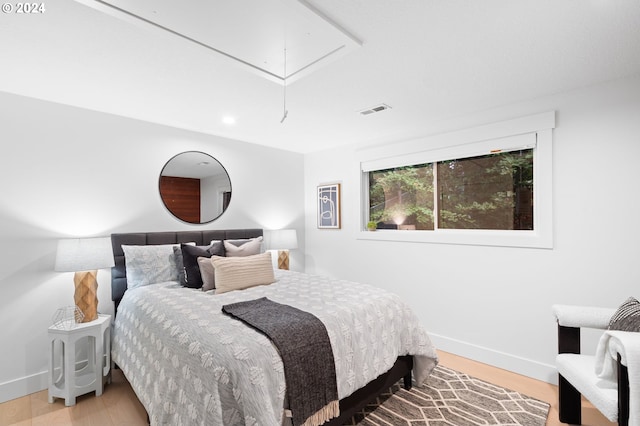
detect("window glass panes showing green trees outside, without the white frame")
[369,149,533,230]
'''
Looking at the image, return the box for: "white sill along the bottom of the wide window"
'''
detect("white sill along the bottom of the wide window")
[356,229,553,249]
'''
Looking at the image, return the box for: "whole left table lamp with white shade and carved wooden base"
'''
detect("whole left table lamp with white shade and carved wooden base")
[55,237,114,322]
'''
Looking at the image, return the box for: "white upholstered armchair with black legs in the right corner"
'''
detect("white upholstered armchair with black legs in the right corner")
[553,305,640,426]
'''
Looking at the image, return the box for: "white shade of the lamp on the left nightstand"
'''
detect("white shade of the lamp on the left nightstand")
[55,237,114,272]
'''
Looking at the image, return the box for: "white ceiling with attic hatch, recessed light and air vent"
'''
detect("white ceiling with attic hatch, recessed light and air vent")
[0,0,640,153]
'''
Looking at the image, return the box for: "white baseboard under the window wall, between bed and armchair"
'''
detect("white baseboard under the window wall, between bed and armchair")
[429,333,558,385]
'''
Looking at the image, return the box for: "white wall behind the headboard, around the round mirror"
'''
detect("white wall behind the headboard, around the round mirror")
[0,93,304,402]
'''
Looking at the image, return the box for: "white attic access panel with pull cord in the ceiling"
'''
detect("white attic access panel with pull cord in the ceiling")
[76,0,362,84]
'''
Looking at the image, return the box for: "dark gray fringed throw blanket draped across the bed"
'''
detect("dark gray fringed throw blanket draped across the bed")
[222,297,340,426]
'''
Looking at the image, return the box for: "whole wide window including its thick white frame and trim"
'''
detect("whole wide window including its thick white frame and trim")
[359,112,555,248]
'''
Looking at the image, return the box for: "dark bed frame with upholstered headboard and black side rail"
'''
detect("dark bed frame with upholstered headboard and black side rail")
[111,229,413,426]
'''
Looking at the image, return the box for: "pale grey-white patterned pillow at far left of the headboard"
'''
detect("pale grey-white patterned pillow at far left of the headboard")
[122,244,180,288]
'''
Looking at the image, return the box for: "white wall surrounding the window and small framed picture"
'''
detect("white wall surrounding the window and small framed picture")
[305,76,640,382]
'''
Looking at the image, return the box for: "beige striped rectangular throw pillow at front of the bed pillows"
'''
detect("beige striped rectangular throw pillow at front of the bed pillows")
[211,252,275,294]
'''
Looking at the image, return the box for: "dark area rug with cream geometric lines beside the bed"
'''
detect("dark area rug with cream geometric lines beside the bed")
[351,366,549,426]
